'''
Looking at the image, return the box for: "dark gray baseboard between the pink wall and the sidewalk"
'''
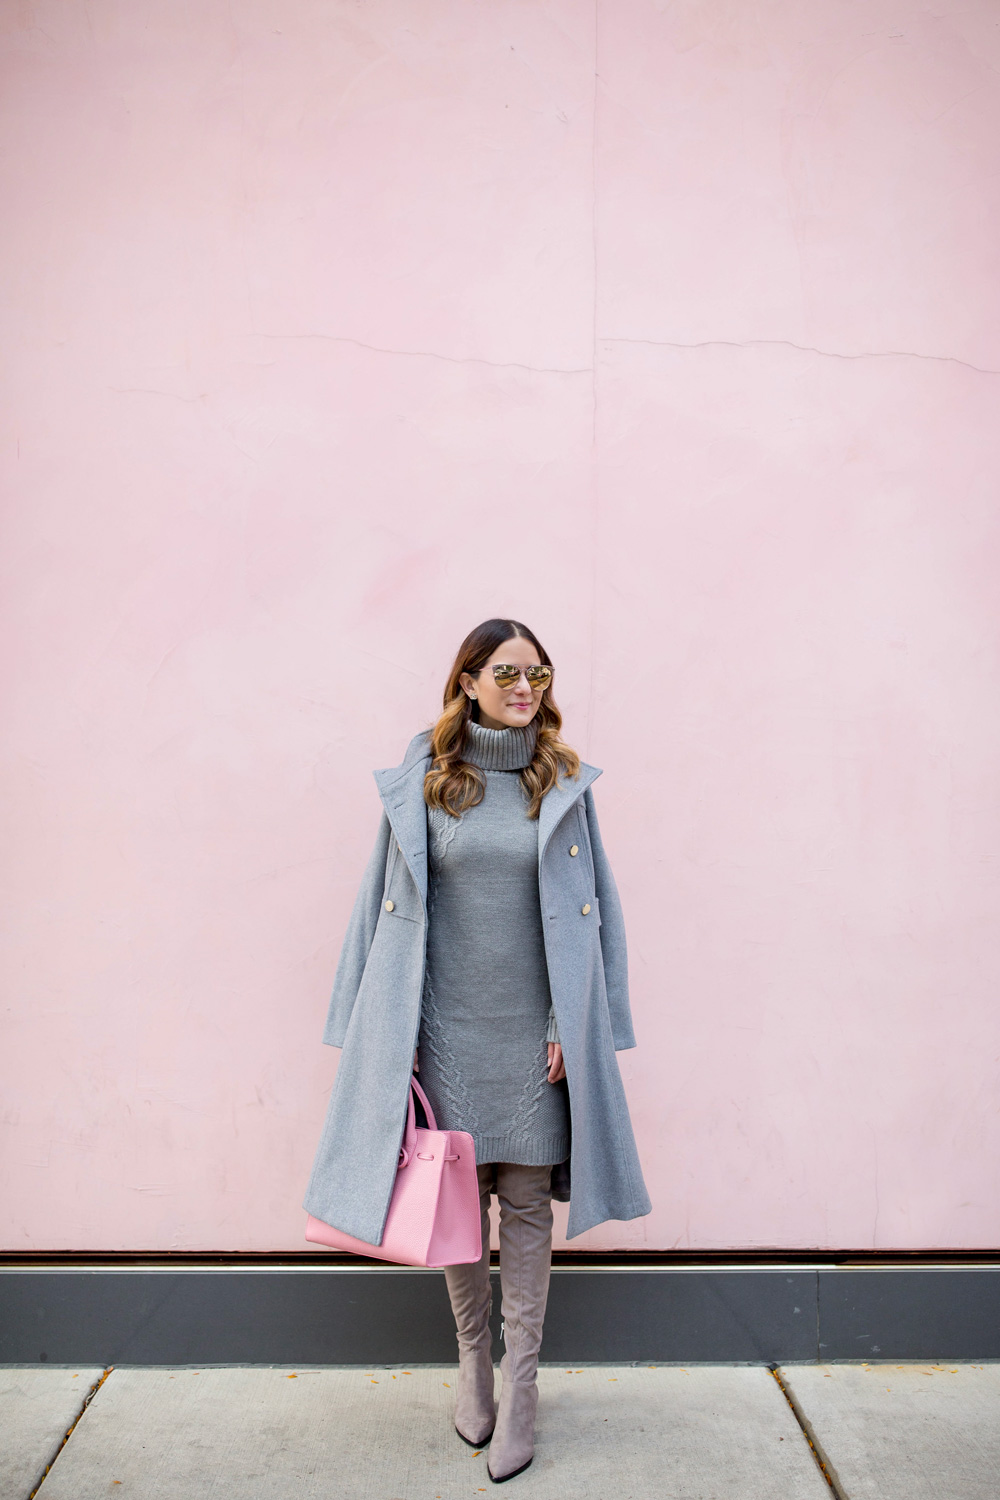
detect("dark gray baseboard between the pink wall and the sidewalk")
[7,1259,1000,1365]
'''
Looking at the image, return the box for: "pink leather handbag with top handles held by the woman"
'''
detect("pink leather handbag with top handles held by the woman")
[306,1077,483,1266]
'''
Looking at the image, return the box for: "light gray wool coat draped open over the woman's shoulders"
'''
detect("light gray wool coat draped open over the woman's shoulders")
[304,734,651,1245]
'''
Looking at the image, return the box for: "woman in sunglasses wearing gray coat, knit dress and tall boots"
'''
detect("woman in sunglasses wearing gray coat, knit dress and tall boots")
[306,620,649,1484]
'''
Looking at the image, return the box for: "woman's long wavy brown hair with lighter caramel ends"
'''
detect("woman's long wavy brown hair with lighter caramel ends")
[424,620,580,818]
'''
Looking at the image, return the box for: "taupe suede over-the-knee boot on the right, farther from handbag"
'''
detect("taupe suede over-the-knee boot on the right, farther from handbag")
[486,1163,552,1484]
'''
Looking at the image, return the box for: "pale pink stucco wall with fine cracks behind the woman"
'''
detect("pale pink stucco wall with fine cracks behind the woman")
[0,0,1000,1250]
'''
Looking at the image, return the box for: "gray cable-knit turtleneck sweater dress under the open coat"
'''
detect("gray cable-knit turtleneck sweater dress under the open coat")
[418,723,570,1167]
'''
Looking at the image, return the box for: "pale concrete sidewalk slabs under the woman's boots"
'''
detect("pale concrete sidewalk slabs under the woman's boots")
[0,1365,1000,1500]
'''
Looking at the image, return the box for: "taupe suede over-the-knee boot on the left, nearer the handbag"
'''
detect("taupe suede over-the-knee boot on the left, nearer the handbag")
[444,1166,496,1448]
